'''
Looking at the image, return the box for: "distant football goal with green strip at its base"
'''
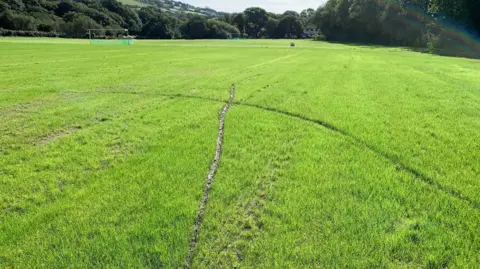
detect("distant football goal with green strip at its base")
[87,29,133,45]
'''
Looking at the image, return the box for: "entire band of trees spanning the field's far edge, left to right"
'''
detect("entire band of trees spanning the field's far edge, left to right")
[0,0,480,55]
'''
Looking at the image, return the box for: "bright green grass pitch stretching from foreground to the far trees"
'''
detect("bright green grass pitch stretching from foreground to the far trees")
[0,39,480,268]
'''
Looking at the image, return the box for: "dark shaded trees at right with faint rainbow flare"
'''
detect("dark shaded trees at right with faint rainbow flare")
[314,0,480,54]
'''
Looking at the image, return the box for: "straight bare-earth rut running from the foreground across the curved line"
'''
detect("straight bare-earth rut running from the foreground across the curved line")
[185,84,235,268]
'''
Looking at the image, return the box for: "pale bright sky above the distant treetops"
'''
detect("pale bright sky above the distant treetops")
[181,0,326,13]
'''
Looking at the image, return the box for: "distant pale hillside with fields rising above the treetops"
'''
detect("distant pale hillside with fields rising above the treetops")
[119,0,226,18]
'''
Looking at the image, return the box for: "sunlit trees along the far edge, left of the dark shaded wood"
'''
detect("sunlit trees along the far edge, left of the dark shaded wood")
[0,0,315,39]
